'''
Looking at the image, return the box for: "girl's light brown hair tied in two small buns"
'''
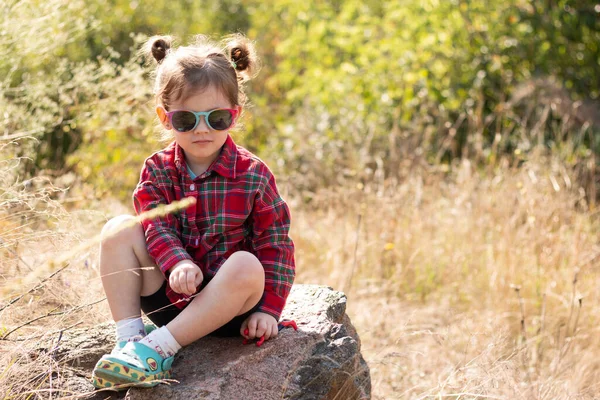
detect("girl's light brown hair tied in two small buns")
[142,34,259,110]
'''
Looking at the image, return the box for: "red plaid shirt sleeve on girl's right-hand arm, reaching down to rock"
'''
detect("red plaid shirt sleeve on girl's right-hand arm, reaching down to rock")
[252,171,296,320]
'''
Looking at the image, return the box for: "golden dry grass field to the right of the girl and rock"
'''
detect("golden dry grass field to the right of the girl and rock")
[294,152,600,399]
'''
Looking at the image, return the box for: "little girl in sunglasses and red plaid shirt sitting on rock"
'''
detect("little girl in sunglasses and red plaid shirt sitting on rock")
[93,35,295,388]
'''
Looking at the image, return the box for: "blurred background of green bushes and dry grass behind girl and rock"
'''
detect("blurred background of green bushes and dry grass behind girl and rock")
[0,0,600,399]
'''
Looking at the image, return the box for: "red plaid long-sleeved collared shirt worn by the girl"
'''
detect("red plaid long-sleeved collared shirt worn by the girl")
[133,136,295,320]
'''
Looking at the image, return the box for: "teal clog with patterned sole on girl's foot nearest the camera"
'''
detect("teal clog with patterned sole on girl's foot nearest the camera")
[92,342,175,390]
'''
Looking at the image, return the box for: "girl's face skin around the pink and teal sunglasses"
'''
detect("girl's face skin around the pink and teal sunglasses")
[158,86,242,172]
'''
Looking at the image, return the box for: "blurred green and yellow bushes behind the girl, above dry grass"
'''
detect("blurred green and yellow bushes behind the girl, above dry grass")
[0,0,600,196]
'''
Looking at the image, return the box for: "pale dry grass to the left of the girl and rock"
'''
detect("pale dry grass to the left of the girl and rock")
[0,149,108,399]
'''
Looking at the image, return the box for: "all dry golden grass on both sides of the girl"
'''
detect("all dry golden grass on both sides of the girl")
[0,148,600,399]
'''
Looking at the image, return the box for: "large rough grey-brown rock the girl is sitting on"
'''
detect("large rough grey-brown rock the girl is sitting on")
[59,285,371,400]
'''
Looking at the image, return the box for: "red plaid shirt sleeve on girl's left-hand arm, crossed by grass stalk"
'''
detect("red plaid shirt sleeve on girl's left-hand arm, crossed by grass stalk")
[133,160,193,275]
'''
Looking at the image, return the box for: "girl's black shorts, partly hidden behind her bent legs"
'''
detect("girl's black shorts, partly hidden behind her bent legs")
[140,281,258,337]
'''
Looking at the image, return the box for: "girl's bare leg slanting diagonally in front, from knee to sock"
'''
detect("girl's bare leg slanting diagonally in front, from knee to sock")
[167,251,265,346]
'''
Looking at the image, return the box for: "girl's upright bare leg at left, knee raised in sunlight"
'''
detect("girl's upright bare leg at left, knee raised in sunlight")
[100,215,165,321]
